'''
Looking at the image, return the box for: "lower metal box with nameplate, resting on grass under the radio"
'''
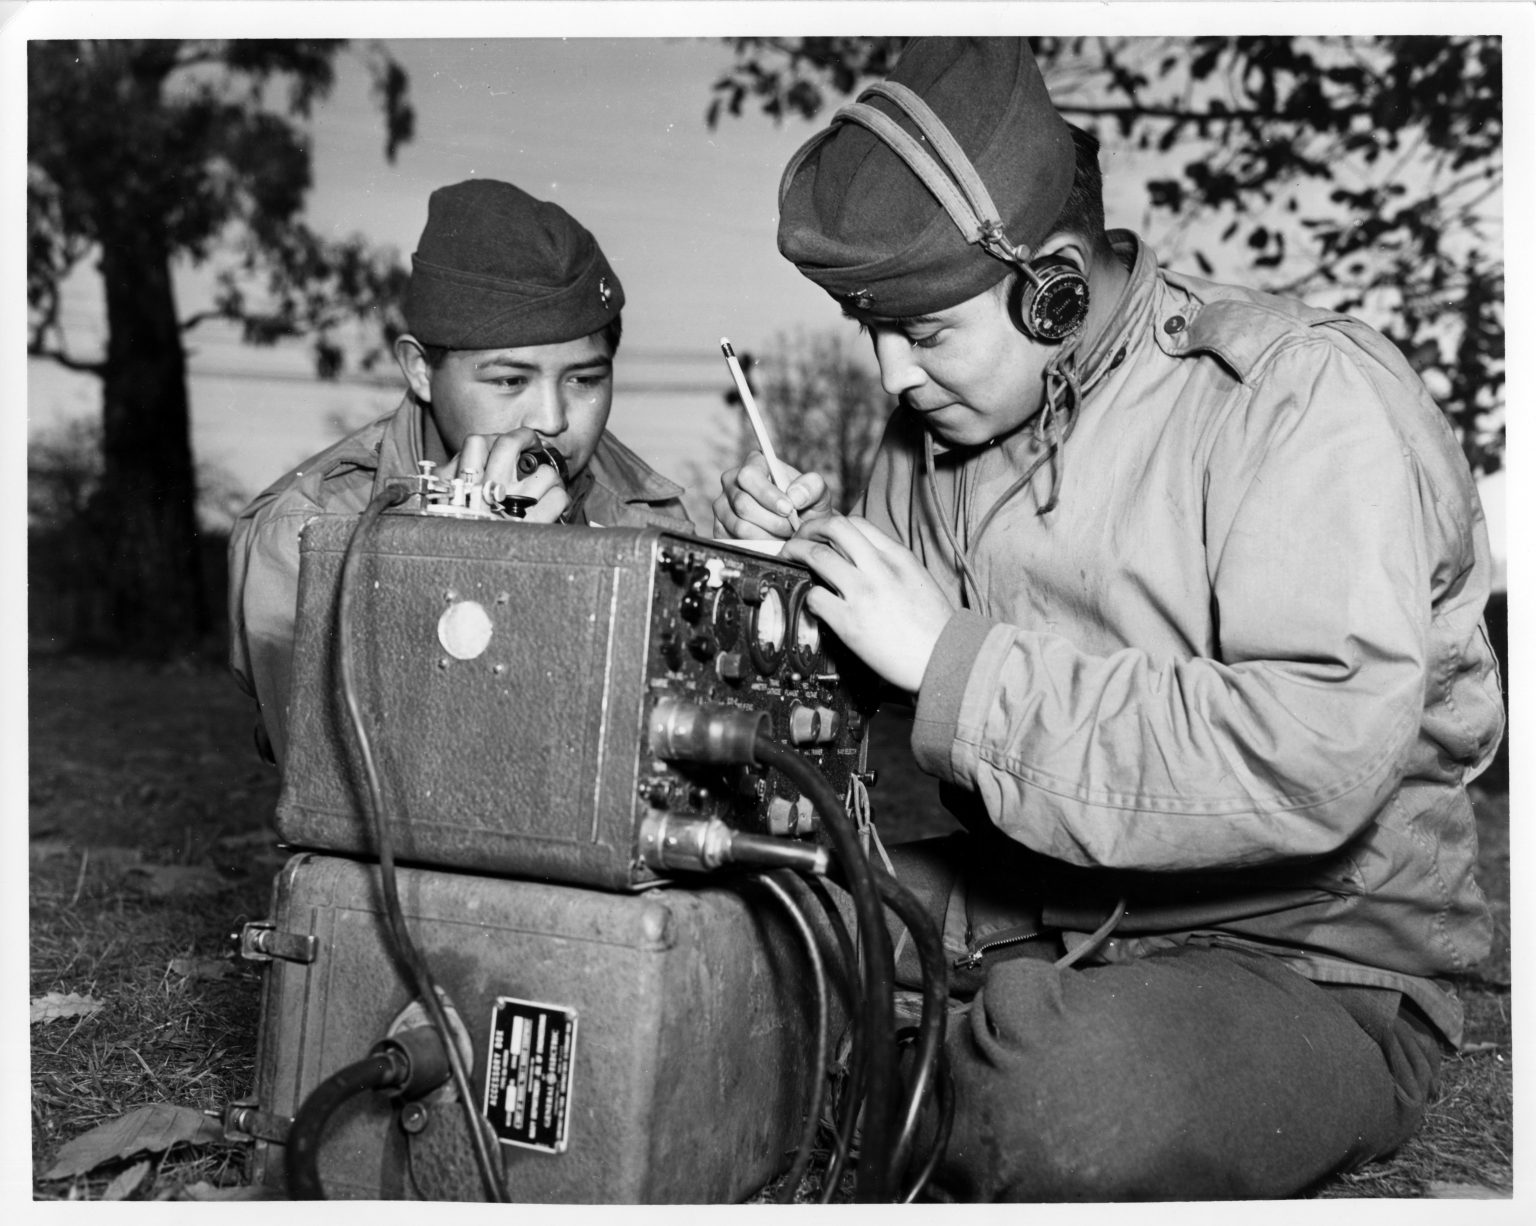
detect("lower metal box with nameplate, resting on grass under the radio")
[247,853,843,1204]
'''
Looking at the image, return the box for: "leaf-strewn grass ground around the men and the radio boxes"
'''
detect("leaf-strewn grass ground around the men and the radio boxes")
[29,658,1513,1200]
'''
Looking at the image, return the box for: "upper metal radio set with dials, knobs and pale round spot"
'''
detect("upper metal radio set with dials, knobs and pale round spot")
[278,513,879,890]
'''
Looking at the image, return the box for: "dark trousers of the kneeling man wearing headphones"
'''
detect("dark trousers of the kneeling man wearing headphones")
[891,836,1441,1201]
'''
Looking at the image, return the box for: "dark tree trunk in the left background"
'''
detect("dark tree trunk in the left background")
[92,224,210,658]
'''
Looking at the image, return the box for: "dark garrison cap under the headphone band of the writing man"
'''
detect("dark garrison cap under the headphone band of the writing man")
[779,38,1075,316]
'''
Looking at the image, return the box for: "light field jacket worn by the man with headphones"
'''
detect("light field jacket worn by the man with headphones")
[865,232,1504,1042]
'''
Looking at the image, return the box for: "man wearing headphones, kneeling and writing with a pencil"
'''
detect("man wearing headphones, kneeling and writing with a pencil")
[714,38,1504,1200]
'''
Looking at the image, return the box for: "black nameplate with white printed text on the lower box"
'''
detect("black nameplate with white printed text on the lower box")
[485,996,576,1154]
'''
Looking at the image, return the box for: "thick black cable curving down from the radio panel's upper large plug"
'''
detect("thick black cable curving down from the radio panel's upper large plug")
[753,736,895,1203]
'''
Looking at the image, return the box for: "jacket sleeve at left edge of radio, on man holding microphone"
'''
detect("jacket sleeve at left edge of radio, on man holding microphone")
[229,499,316,765]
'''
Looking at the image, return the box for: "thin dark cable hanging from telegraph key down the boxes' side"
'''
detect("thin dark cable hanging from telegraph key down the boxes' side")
[336,482,507,1203]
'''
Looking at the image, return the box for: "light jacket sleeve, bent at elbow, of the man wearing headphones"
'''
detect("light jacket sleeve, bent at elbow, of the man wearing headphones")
[912,341,1455,871]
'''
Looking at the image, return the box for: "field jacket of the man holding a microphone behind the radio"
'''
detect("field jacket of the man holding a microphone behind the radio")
[229,398,693,764]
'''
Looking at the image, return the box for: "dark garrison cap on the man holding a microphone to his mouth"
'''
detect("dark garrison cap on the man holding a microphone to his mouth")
[404,178,624,349]
